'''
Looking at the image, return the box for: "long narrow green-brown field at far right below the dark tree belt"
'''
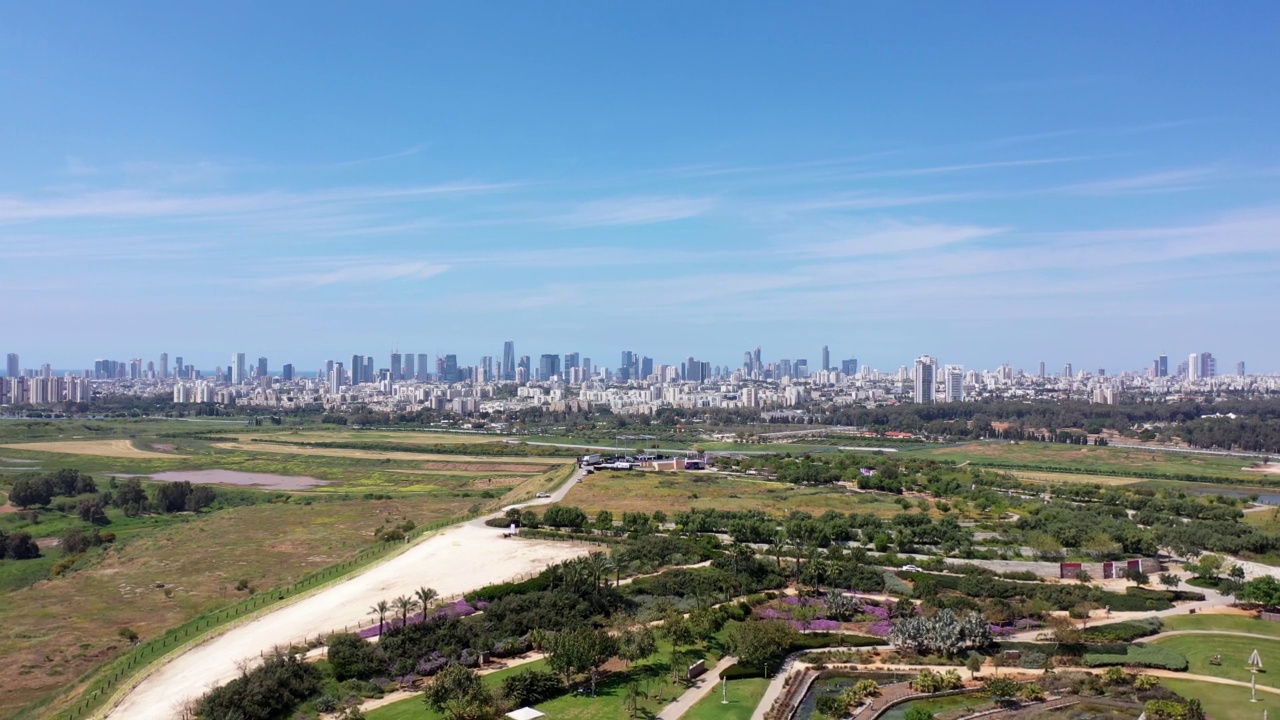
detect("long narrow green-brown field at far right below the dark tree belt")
[901,442,1266,483]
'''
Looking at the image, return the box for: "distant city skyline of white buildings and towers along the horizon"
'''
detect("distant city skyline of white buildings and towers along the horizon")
[0,341,1280,415]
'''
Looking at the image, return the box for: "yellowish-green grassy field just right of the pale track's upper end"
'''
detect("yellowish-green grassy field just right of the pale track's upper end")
[564,470,902,516]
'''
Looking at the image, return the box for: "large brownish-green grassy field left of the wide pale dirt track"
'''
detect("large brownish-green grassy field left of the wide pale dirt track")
[0,497,471,716]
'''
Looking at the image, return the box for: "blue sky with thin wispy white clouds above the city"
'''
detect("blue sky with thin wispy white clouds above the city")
[0,0,1280,372]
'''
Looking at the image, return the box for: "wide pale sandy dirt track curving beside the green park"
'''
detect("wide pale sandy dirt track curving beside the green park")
[100,470,586,720]
